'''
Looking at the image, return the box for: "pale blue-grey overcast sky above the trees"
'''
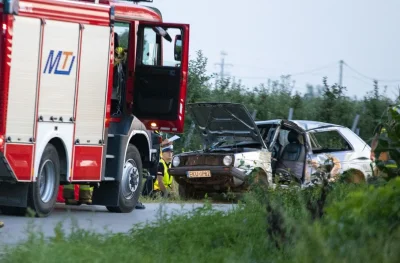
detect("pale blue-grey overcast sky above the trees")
[143,0,400,98]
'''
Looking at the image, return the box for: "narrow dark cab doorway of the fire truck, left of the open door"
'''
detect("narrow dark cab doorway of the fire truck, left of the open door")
[111,22,130,116]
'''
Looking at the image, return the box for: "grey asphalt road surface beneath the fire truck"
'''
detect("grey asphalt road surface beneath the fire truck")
[0,203,232,247]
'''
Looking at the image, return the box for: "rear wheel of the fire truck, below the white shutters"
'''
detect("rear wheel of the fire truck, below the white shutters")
[28,144,60,217]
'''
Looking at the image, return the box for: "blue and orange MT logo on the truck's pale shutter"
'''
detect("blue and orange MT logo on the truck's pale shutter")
[43,50,75,76]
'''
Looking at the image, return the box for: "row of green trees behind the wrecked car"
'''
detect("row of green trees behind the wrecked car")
[164,50,399,152]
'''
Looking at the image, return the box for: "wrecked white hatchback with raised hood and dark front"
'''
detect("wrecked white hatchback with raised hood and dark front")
[169,103,372,197]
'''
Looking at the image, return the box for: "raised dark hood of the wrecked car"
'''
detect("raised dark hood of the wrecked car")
[187,102,266,147]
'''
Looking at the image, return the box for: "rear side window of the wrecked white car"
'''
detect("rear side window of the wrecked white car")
[312,130,352,152]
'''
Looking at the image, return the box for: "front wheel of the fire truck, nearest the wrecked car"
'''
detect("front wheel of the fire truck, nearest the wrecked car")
[107,144,143,213]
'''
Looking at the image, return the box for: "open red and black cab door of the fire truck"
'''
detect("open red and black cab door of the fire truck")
[132,22,189,133]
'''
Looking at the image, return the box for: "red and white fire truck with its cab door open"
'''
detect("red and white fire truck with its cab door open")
[0,0,189,216]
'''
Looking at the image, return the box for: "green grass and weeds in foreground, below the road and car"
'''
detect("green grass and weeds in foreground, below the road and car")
[1,178,400,263]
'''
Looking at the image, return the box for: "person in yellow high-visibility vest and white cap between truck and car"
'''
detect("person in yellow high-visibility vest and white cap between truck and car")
[153,145,173,197]
